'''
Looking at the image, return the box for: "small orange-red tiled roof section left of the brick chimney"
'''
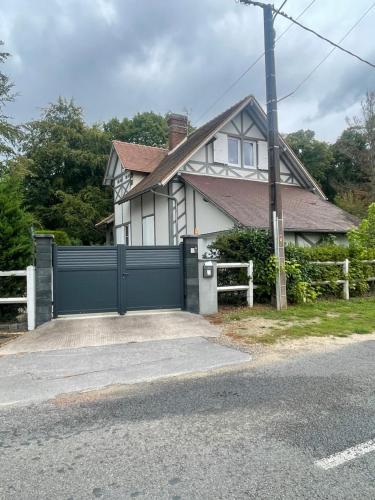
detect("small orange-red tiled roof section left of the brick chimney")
[113,141,168,173]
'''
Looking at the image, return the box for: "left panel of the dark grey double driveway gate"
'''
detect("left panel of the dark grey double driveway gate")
[54,246,118,317]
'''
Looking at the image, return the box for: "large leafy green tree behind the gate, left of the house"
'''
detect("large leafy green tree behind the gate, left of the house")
[21,97,112,244]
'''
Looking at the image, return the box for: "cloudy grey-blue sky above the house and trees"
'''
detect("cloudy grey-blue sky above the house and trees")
[0,0,375,142]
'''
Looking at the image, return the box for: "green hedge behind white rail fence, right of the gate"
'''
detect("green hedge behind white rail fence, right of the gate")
[207,228,375,304]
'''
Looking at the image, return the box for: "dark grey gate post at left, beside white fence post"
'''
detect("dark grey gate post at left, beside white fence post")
[34,234,54,326]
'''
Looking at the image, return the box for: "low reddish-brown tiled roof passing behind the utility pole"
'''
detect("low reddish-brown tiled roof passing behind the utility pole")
[181,174,358,233]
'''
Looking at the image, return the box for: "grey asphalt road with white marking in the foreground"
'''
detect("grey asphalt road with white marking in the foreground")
[0,341,375,500]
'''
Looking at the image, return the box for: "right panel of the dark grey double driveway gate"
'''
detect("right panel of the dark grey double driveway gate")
[125,246,183,311]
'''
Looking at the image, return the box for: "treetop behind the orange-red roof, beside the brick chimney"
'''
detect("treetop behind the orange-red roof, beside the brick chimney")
[103,111,168,147]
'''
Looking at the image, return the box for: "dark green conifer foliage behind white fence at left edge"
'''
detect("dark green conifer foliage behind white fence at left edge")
[0,175,33,320]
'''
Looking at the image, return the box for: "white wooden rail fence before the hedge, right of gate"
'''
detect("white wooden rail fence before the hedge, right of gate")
[217,259,375,307]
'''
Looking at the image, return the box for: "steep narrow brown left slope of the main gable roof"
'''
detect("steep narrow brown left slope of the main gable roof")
[125,96,254,200]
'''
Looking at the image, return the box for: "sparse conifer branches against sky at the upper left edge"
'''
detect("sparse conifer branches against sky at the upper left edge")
[0,41,21,171]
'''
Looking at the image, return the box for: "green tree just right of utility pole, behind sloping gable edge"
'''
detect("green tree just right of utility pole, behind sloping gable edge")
[285,130,333,197]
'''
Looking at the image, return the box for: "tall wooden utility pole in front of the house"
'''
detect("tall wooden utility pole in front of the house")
[240,0,287,310]
